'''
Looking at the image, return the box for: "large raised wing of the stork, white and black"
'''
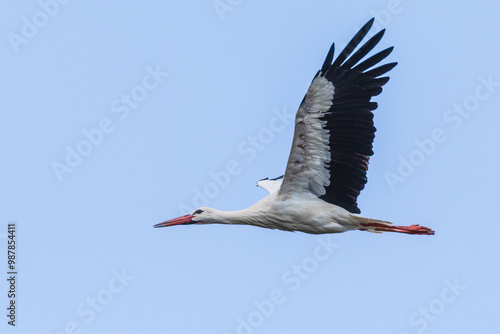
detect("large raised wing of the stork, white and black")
[280,19,397,213]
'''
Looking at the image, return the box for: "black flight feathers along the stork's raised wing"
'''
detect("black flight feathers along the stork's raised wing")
[318,19,397,213]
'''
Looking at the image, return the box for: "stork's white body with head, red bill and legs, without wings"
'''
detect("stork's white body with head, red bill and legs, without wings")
[159,188,433,234]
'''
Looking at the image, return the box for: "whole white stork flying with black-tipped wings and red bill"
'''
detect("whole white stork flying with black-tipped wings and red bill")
[154,18,434,235]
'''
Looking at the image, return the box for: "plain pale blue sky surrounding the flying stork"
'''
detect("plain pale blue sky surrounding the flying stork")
[0,0,500,334]
